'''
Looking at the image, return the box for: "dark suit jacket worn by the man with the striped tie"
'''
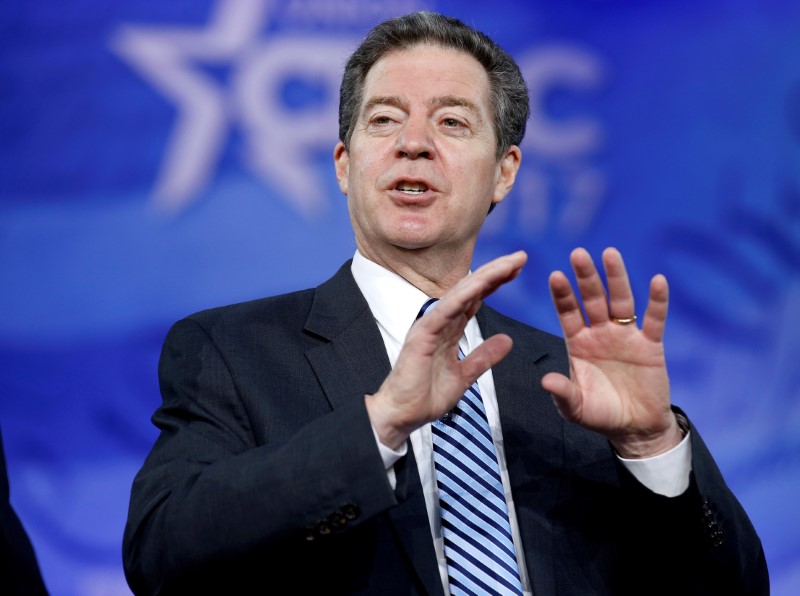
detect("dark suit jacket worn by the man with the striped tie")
[124,262,768,595]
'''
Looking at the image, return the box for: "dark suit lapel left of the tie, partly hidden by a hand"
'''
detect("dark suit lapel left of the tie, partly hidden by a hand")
[305,261,442,594]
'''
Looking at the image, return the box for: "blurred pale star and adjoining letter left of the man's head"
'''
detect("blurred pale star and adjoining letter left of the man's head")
[111,0,352,217]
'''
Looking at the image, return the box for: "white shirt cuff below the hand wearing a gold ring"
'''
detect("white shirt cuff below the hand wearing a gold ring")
[620,432,692,497]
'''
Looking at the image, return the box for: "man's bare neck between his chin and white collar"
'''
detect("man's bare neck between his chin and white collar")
[356,242,473,298]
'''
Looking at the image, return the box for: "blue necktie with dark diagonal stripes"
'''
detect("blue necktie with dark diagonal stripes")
[417,298,522,595]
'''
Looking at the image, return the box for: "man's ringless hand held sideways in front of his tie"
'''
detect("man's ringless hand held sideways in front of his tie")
[366,251,528,449]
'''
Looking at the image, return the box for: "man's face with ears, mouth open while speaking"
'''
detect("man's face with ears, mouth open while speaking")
[334,45,520,263]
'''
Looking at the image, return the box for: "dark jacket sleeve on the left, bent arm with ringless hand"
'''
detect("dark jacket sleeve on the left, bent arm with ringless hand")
[123,319,397,593]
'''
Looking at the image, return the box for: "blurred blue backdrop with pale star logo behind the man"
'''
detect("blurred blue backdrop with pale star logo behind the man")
[0,0,800,595]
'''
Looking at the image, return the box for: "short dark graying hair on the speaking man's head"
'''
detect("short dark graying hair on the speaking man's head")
[339,12,530,159]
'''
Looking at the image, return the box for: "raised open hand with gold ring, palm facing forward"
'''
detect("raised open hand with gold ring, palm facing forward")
[542,248,681,457]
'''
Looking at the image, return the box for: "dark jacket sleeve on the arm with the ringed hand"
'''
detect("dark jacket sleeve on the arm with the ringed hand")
[608,414,769,596]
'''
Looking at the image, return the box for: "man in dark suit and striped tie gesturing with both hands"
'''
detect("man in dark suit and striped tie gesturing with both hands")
[124,13,768,594]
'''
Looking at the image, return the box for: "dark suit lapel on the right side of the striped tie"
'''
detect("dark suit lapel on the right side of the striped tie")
[477,306,564,594]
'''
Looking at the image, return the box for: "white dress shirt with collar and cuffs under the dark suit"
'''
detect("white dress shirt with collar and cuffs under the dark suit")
[351,251,691,594]
